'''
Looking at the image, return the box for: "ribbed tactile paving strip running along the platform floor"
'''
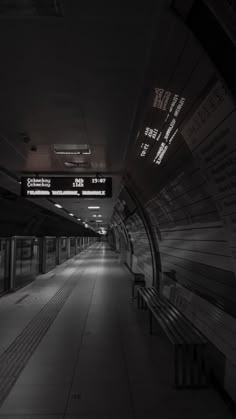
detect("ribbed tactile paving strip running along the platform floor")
[0,272,82,406]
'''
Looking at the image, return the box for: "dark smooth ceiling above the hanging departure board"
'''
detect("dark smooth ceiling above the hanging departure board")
[0,0,168,233]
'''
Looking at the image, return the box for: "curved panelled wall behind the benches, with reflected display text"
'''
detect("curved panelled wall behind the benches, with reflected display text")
[115,4,236,400]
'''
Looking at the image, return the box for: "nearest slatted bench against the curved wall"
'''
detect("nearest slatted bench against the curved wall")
[137,287,208,388]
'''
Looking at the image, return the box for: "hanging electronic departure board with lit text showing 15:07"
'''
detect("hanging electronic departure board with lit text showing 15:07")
[21,176,112,198]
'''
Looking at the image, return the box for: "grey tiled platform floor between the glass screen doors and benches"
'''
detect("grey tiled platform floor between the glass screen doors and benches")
[0,243,233,419]
